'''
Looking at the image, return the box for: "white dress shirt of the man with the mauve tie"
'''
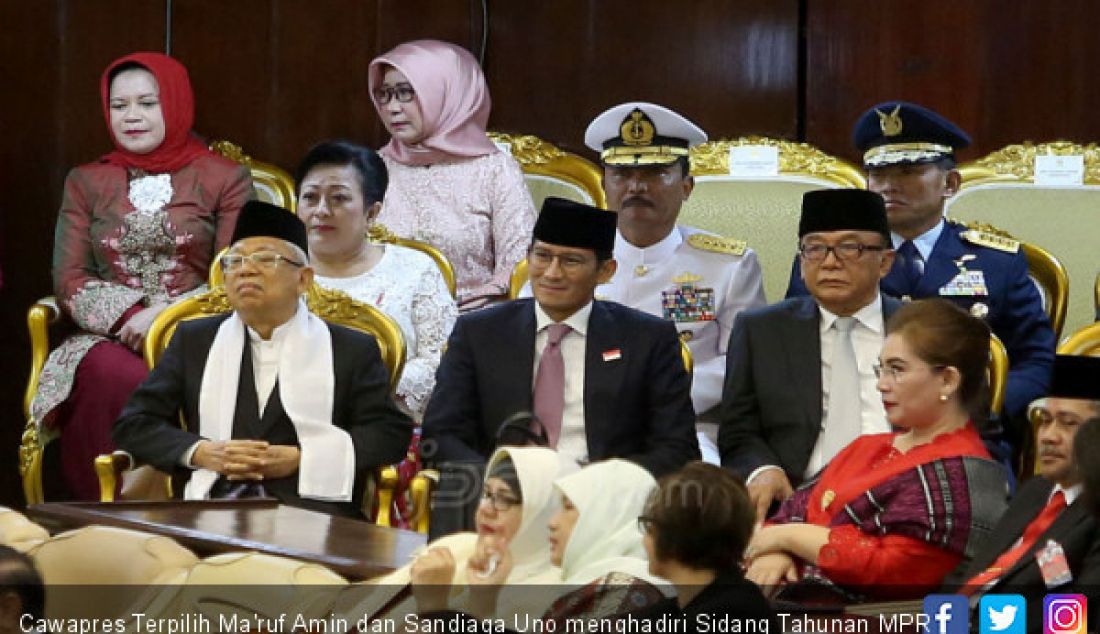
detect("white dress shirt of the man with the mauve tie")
[531,302,592,464]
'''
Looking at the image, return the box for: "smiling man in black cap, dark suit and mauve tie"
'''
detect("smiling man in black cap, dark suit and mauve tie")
[424,198,699,476]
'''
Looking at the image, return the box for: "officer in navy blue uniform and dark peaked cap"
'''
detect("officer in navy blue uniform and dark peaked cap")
[787,101,1055,440]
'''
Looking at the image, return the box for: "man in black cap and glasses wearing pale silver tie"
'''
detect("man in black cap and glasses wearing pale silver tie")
[718,189,900,521]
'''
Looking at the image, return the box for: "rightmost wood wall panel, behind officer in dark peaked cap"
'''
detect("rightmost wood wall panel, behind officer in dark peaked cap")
[803,0,1100,166]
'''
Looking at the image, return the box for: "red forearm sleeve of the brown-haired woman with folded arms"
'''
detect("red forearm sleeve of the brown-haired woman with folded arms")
[817,525,963,595]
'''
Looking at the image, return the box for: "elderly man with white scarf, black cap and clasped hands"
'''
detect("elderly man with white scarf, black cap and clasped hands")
[113,201,411,516]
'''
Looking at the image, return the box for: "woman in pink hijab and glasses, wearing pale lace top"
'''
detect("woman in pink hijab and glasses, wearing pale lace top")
[370,40,536,311]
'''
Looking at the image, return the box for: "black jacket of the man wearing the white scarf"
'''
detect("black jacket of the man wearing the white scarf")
[113,315,413,513]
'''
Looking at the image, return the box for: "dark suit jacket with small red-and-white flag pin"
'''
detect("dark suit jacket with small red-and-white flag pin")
[424,299,700,476]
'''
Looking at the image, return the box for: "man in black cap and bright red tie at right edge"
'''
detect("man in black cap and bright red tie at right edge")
[944,356,1100,632]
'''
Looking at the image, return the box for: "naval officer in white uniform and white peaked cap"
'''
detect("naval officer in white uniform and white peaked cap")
[584,101,765,464]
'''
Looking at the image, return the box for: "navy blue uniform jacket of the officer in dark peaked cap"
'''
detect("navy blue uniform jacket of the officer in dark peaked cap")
[787,217,1056,420]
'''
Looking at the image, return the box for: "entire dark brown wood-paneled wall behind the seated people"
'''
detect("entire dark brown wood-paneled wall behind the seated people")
[0,0,1100,505]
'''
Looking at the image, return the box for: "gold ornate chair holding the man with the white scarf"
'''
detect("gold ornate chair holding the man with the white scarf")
[95,284,406,526]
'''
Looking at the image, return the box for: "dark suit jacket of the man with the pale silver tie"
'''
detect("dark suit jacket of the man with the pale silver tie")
[718,296,901,485]
